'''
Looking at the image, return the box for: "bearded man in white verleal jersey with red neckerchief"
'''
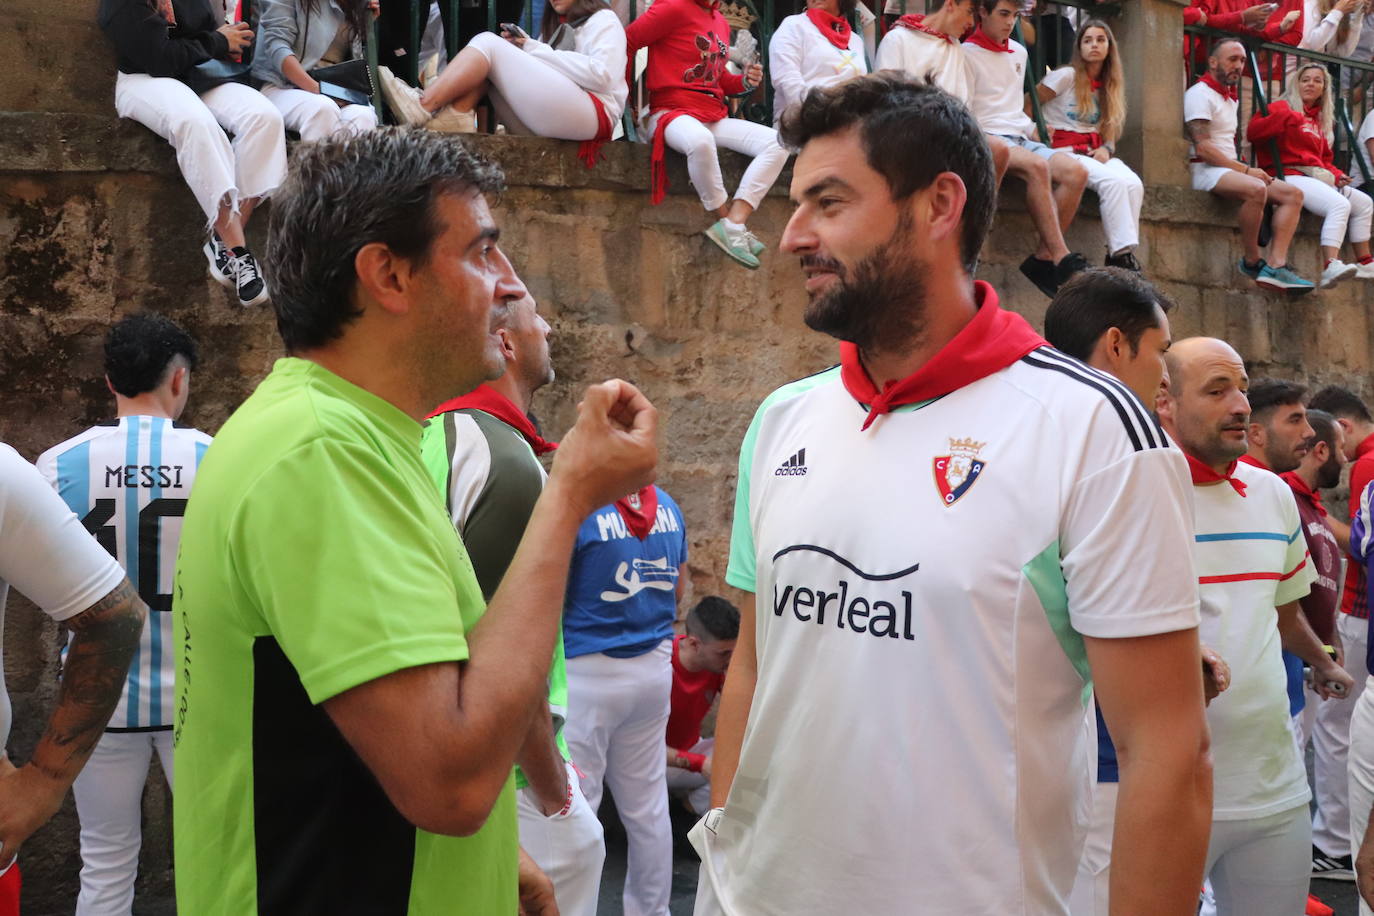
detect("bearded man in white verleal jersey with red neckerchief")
[692,73,1210,916]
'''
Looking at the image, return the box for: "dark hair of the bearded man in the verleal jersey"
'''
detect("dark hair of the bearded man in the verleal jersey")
[779,70,998,273]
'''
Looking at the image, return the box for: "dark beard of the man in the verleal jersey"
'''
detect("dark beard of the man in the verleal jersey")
[801,209,929,352]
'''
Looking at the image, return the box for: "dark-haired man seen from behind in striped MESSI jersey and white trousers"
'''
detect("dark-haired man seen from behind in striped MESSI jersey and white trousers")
[37,313,210,916]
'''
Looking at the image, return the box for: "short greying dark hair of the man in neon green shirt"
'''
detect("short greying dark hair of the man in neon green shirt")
[265,128,504,352]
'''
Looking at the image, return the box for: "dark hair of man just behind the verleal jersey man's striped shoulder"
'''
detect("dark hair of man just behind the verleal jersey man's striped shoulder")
[1044,268,1173,363]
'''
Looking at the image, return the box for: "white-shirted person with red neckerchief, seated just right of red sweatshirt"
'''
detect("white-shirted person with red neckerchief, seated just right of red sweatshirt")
[768,0,868,124]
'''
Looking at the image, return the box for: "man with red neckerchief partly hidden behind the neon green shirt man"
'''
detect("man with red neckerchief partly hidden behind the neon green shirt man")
[420,294,606,916]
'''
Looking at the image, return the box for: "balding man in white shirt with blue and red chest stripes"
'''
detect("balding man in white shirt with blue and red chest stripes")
[1159,338,1351,916]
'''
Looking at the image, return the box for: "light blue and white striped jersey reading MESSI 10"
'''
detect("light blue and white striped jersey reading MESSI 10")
[37,416,210,732]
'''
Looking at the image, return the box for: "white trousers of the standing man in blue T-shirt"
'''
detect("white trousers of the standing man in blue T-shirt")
[563,640,673,916]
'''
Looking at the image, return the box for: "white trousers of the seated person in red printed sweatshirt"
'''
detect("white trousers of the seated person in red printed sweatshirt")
[644,111,787,210]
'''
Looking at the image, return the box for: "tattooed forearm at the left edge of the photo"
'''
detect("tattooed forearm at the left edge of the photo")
[0,580,147,864]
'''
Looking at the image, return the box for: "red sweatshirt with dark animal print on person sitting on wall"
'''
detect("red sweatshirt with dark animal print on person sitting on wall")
[625,0,745,117]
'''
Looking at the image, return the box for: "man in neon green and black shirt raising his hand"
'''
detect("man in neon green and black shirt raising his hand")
[173,129,657,916]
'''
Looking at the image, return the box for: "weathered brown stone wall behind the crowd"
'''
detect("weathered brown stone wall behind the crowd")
[0,0,1374,916]
